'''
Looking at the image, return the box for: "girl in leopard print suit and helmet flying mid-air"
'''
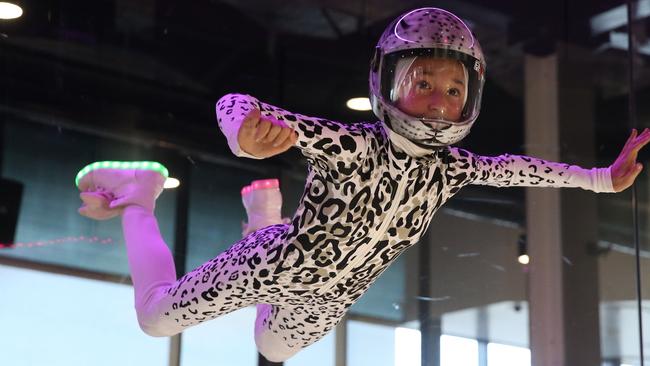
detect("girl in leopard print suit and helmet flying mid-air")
[78,8,650,362]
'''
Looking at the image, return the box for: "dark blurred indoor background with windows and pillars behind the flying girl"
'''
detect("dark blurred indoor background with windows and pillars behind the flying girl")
[0,0,650,366]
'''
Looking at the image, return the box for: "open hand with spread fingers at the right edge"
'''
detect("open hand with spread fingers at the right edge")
[610,128,650,192]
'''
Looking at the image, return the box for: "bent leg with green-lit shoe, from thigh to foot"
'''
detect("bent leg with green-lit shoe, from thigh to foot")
[79,169,286,336]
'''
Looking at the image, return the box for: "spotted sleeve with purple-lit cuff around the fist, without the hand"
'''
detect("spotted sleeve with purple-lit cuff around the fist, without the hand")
[216,94,366,173]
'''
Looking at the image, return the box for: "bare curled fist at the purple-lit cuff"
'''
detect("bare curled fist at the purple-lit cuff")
[237,108,298,158]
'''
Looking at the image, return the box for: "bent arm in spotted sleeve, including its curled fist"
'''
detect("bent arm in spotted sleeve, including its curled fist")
[216,94,368,176]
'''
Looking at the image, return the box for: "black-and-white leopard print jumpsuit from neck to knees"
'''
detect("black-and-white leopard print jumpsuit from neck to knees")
[133,94,613,361]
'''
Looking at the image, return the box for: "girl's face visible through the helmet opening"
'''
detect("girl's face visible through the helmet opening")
[396,57,467,122]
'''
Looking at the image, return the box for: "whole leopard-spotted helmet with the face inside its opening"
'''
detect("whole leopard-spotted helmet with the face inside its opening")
[370,8,485,149]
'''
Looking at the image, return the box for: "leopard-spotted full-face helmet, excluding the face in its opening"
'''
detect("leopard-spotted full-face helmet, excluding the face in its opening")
[370,8,485,149]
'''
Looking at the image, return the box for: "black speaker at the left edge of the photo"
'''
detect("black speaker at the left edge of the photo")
[0,178,23,246]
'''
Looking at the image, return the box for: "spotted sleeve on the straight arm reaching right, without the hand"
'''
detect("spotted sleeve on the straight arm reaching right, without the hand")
[449,147,614,192]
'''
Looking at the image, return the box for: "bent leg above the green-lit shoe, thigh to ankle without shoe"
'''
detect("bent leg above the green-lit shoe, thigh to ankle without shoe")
[123,206,285,336]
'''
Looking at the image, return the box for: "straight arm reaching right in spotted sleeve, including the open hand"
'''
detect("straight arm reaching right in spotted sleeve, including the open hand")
[448,129,650,193]
